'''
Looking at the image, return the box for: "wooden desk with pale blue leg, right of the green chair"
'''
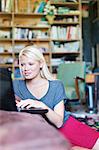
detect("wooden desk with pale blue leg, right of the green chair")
[86,73,99,113]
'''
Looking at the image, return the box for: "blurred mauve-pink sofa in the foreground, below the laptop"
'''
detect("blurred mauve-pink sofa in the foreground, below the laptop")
[0,110,71,150]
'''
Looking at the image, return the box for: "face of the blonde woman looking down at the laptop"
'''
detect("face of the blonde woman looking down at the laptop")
[20,55,42,79]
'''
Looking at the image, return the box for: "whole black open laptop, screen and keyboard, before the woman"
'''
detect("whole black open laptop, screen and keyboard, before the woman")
[0,68,48,115]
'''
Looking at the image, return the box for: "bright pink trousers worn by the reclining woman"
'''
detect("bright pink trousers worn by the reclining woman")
[58,116,99,149]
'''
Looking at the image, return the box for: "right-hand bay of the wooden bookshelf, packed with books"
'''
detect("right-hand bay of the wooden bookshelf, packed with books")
[51,0,83,72]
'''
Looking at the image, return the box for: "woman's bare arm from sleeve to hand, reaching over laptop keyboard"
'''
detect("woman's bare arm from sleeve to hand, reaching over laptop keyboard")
[17,99,64,128]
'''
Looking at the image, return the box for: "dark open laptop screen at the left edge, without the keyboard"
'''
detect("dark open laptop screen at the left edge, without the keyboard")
[0,68,17,111]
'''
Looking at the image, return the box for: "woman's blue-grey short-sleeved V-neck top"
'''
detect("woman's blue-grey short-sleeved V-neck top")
[13,80,70,122]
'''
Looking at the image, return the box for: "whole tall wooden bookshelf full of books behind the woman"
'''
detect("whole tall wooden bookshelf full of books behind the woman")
[0,0,83,79]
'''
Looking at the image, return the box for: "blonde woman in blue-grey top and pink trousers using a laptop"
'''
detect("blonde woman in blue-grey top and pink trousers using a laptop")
[13,46,99,150]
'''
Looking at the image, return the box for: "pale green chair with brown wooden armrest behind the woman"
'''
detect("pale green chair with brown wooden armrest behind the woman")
[57,62,86,101]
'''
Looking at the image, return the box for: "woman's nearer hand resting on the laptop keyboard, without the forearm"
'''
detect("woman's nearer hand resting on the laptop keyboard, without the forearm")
[16,99,45,109]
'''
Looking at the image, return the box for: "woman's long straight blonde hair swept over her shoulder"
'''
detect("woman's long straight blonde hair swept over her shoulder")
[19,45,54,80]
